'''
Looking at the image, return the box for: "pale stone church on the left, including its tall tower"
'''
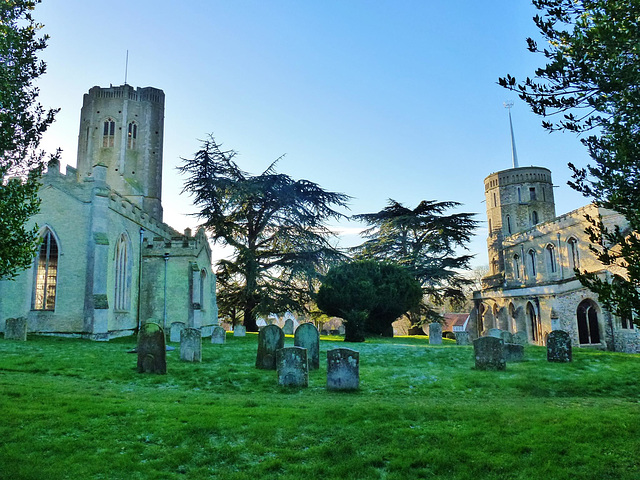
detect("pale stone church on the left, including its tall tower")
[0,84,218,340]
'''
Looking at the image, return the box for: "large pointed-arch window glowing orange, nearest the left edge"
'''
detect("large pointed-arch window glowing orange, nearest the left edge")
[33,228,58,310]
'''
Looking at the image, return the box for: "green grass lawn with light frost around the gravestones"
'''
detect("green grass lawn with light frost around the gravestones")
[0,334,640,480]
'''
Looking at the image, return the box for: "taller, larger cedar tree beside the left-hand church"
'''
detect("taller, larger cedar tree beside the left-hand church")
[180,137,349,331]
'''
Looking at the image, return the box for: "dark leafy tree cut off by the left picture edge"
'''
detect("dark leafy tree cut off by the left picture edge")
[0,0,57,279]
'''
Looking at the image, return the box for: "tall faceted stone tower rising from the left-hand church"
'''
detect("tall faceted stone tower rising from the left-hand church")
[77,84,164,220]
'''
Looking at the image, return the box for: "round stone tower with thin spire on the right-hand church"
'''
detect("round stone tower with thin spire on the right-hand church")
[484,167,556,275]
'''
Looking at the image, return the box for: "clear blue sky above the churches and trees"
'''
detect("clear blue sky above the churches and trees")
[35,0,588,265]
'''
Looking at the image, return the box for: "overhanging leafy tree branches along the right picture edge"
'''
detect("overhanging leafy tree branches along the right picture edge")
[499,0,640,326]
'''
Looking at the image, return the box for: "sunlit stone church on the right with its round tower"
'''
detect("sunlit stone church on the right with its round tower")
[468,167,640,352]
